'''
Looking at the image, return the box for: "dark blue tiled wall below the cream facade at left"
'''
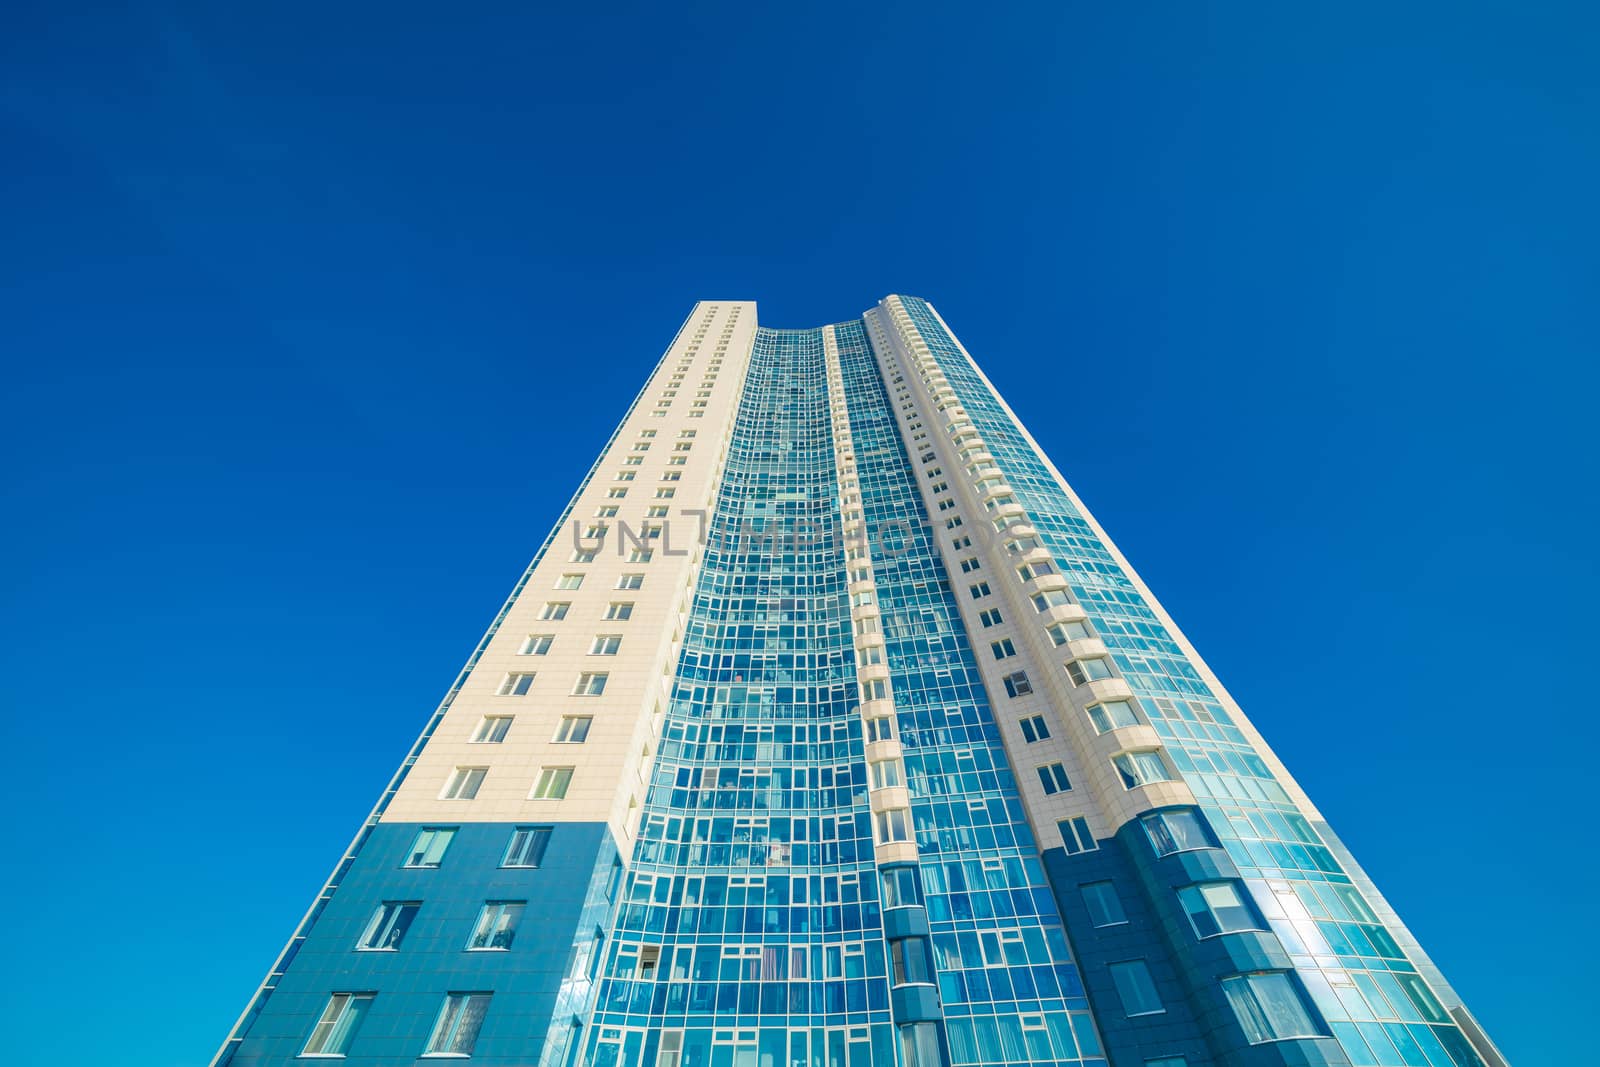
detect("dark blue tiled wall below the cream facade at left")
[232,822,614,1067]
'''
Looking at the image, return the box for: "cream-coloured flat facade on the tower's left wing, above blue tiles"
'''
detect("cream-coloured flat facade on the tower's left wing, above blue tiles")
[382,301,755,856]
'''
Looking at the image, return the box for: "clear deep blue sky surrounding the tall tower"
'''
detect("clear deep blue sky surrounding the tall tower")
[0,0,1600,1067]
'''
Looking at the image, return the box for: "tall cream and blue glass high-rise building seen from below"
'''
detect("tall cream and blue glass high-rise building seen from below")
[216,296,1504,1067]
